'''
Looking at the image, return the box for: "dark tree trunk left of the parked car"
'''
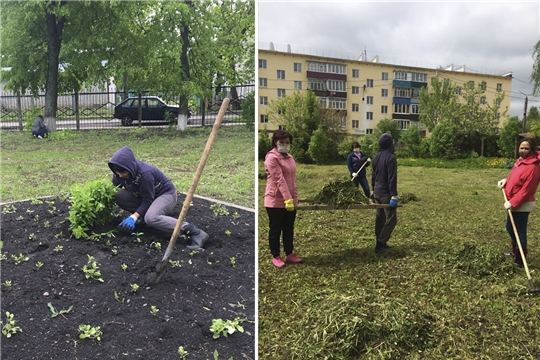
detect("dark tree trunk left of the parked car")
[45,0,67,131]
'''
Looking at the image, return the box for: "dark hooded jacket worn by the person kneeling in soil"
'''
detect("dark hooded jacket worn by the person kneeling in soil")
[109,147,176,216]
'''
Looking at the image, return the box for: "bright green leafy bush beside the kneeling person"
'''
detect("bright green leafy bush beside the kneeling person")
[68,179,116,239]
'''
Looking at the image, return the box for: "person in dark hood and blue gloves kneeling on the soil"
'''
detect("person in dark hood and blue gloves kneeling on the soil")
[109,147,208,250]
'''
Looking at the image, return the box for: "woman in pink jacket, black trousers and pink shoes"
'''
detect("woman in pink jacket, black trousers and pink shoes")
[264,130,302,268]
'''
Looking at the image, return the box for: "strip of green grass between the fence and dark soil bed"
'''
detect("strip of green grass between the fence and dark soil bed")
[0,126,255,208]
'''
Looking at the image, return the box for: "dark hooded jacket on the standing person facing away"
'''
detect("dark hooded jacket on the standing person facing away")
[371,133,397,197]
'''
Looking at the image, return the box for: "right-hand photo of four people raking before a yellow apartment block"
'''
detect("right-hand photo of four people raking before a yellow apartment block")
[256,0,540,360]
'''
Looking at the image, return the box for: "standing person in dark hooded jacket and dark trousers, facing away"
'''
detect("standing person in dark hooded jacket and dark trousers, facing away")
[371,133,398,253]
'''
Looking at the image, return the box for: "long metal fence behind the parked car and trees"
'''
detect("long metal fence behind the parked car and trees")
[0,84,255,130]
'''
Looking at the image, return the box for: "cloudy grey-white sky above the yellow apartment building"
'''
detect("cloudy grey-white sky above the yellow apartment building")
[257,0,540,118]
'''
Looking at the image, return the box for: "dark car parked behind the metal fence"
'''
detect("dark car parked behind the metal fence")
[113,96,191,126]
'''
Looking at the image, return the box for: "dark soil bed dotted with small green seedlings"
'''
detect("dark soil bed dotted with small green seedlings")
[1,194,255,360]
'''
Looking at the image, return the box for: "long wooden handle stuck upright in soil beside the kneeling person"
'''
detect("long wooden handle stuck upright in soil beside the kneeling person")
[161,98,229,263]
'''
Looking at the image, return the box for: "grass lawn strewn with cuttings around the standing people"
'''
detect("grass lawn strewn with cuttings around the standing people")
[258,162,540,360]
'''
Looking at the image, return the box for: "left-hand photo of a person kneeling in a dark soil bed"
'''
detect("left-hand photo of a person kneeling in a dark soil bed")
[0,0,257,360]
